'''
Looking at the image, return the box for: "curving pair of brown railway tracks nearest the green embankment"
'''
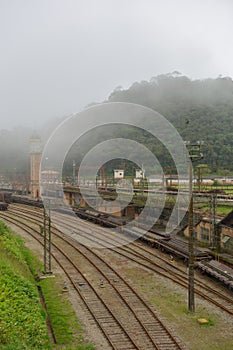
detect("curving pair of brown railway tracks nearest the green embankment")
[0,205,184,350]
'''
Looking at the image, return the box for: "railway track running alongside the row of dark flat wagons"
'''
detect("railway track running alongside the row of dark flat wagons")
[3,205,233,315]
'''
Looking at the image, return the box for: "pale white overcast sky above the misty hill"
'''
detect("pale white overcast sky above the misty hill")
[0,0,233,129]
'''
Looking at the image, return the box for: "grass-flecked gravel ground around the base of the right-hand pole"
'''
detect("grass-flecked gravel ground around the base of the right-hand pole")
[104,257,233,350]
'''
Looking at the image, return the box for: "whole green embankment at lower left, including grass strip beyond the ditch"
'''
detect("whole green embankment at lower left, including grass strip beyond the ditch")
[0,222,94,350]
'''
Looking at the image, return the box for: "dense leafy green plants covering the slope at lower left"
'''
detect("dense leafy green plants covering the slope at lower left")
[0,222,50,350]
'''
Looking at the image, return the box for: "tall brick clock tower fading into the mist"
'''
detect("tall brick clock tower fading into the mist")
[30,133,42,198]
